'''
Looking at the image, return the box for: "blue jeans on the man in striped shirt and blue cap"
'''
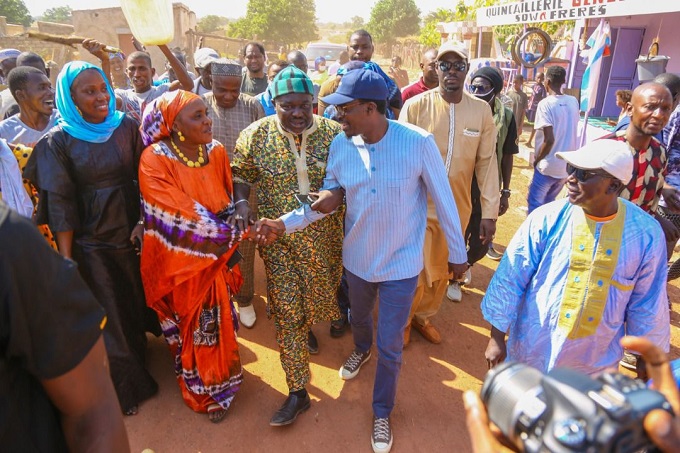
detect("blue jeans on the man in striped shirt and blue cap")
[345,270,418,418]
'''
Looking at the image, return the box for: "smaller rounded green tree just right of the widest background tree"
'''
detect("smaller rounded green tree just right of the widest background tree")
[366,0,420,46]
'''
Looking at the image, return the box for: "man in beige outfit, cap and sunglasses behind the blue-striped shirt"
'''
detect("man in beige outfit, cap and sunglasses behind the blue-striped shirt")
[399,41,500,332]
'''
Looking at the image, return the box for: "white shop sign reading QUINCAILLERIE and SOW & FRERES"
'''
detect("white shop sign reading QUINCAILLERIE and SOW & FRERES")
[477,0,680,27]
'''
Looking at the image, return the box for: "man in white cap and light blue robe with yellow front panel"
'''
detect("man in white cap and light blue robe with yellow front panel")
[482,140,670,374]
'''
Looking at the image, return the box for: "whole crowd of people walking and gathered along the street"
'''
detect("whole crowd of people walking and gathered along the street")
[0,26,680,453]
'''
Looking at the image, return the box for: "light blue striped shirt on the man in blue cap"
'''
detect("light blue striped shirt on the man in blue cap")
[281,121,467,282]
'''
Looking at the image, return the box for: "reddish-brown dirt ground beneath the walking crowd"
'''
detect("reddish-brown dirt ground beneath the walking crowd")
[125,129,680,453]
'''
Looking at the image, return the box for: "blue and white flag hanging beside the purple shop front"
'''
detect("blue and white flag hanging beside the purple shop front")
[581,19,611,112]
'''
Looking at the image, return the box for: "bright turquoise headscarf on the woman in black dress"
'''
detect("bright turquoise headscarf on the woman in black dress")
[54,61,125,143]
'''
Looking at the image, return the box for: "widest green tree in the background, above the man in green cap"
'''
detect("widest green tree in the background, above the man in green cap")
[227,0,318,45]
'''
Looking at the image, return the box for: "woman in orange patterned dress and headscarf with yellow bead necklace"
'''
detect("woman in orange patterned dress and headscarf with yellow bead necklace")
[139,90,274,422]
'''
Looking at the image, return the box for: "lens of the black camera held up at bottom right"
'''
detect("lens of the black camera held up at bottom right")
[482,362,543,439]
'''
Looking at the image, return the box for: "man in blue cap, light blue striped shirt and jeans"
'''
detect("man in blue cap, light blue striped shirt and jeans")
[268,69,467,452]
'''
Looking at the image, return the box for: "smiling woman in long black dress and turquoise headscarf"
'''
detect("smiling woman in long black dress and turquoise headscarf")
[24,61,160,415]
